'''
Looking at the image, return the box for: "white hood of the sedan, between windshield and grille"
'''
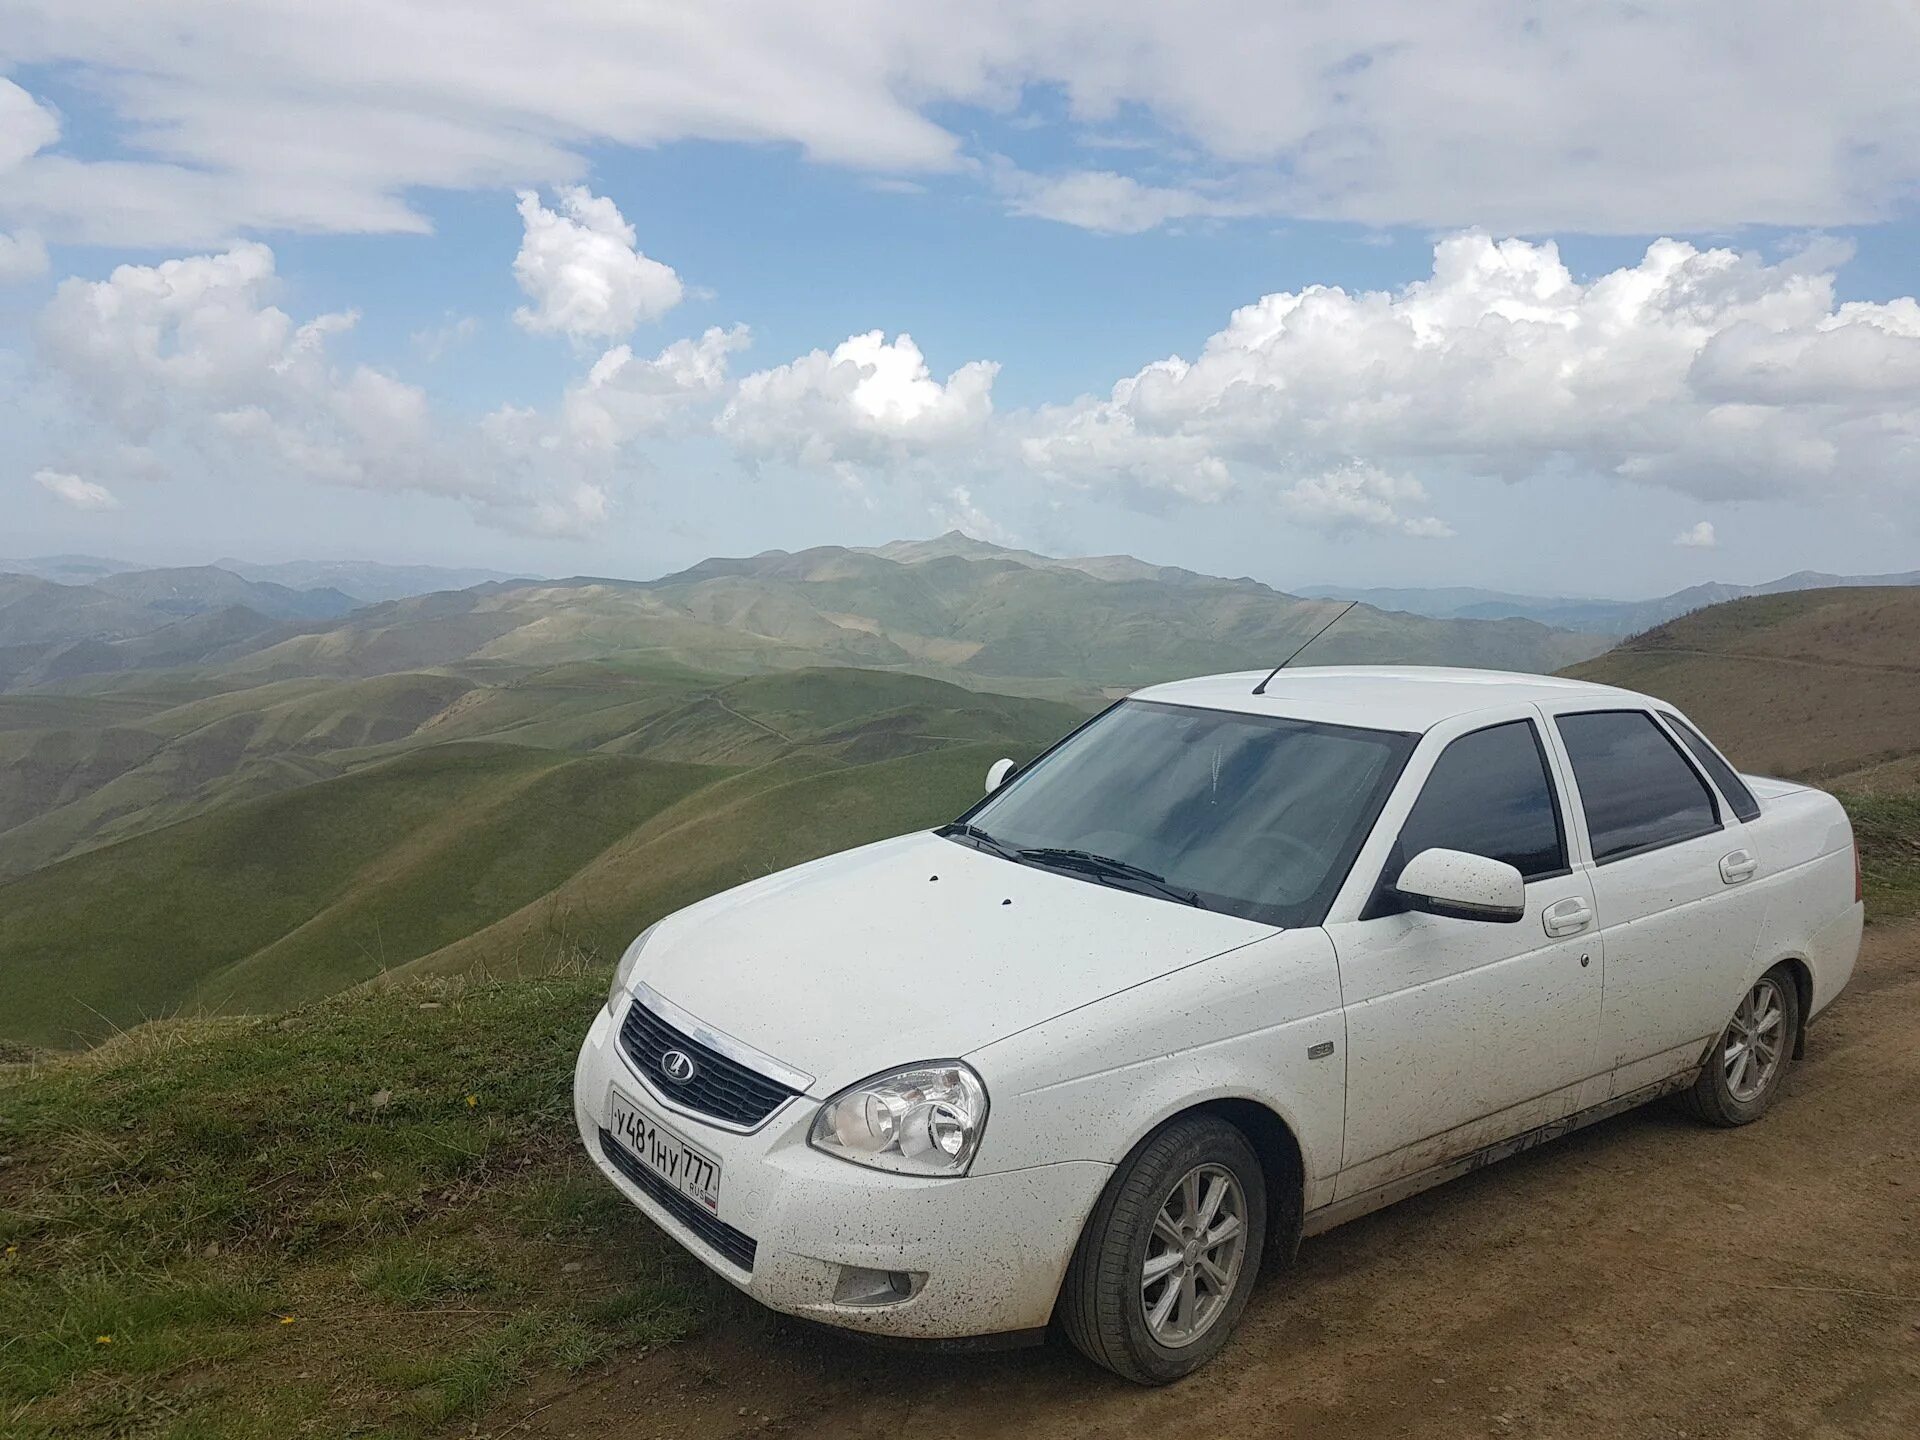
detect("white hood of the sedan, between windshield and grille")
[634,831,1273,1096]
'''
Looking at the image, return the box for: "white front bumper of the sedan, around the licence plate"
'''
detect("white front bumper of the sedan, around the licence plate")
[574,1010,1112,1340]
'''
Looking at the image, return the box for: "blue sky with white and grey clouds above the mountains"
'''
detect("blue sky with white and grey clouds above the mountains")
[0,0,1920,597]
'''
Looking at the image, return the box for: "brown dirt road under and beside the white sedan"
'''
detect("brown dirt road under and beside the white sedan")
[495,924,1920,1440]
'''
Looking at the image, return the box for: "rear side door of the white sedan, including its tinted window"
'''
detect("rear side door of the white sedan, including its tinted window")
[1548,701,1761,1094]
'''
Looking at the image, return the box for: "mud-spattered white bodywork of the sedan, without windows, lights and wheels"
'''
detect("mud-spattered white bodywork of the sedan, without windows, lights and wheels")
[574,670,1860,1336]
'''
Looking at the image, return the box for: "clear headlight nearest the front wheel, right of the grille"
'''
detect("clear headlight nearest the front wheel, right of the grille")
[806,1060,987,1175]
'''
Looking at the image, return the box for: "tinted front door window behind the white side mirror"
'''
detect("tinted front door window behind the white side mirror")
[1390,720,1567,879]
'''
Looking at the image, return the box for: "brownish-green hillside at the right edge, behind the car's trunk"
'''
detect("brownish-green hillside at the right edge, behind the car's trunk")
[1567,589,1920,920]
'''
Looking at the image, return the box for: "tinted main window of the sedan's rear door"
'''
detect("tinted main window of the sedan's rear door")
[1555,710,1720,860]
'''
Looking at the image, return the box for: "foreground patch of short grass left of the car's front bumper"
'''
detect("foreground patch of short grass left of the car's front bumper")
[0,975,710,1440]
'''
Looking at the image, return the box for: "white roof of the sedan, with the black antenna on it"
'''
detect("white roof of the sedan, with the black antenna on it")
[1133,664,1649,732]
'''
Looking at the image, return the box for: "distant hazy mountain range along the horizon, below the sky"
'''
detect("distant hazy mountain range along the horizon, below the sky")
[0,532,1605,697]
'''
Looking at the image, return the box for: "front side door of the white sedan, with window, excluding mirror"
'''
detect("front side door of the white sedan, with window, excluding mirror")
[1327,718,1601,1198]
